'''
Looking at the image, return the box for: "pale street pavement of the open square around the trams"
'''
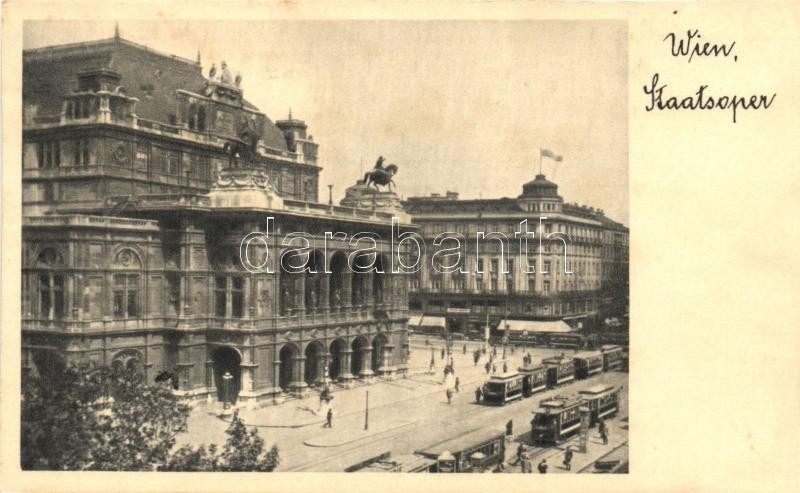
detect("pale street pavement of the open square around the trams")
[178,336,628,473]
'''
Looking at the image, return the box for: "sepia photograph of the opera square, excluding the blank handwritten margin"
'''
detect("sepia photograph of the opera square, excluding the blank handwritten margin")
[15,20,630,474]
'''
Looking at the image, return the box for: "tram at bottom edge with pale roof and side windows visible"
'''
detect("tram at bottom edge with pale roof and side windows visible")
[415,428,506,472]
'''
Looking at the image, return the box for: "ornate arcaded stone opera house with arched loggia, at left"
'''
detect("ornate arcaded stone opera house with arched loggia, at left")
[21,35,410,403]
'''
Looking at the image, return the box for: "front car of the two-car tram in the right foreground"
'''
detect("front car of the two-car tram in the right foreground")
[531,396,586,445]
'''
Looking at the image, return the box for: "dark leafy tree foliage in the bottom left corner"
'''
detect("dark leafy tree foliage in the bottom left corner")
[21,365,278,471]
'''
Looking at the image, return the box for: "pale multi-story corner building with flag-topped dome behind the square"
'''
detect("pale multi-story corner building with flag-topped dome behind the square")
[404,174,628,334]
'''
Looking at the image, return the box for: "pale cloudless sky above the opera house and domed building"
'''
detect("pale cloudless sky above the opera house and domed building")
[23,20,628,224]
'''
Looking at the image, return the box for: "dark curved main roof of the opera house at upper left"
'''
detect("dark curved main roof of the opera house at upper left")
[22,37,287,150]
